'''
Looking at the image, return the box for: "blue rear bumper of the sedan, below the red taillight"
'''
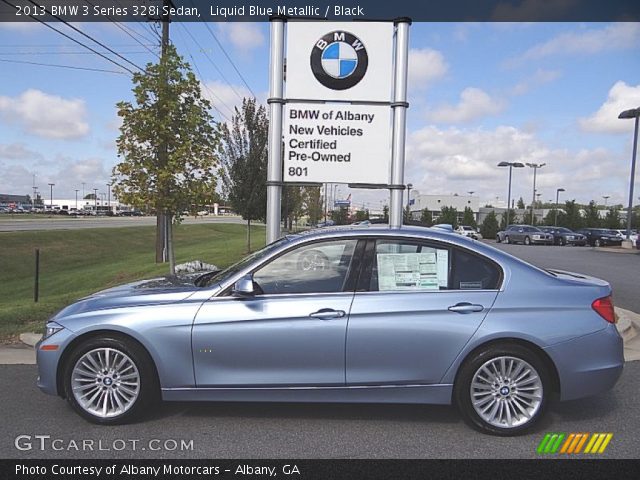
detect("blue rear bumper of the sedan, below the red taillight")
[545,325,624,400]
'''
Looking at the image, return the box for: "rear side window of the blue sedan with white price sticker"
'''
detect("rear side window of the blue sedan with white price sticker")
[369,240,502,292]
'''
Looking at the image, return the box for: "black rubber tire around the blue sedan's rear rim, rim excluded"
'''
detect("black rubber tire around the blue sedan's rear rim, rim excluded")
[453,344,551,436]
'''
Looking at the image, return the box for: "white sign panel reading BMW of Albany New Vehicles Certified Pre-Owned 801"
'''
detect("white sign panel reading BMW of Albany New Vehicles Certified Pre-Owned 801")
[283,103,391,184]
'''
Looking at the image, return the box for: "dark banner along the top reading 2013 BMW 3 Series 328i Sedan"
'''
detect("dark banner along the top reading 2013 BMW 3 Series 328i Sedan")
[0,0,640,22]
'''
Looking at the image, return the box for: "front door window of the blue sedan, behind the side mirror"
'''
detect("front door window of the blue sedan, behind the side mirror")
[253,239,358,295]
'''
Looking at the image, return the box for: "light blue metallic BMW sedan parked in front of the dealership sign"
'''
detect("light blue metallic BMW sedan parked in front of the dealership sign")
[37,226,623,435]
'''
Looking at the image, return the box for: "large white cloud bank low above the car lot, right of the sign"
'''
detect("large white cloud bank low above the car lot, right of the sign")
[405,125,628,203]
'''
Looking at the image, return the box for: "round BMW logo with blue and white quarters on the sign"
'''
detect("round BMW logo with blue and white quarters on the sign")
[311,30,369,90]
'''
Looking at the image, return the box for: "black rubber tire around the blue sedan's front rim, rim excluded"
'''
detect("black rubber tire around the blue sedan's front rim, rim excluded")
[63,335,160,425]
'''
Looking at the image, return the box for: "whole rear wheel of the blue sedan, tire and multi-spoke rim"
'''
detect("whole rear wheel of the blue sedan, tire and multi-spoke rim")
[454,345,550,436]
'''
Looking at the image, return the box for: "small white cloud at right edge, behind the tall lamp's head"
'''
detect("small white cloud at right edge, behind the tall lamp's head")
[578,82,640,133]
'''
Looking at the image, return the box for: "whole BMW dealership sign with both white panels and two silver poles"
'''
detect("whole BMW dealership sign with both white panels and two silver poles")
[267,17,410,243]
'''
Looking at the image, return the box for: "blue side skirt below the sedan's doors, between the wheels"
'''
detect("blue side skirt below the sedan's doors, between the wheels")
[162,384,453,405]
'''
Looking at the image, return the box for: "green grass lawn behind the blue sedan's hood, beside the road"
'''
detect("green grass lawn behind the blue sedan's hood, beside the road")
[0,224,265,339]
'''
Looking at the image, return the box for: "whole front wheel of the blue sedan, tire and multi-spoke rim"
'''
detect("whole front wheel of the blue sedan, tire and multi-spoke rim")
[64,337,158,424]
